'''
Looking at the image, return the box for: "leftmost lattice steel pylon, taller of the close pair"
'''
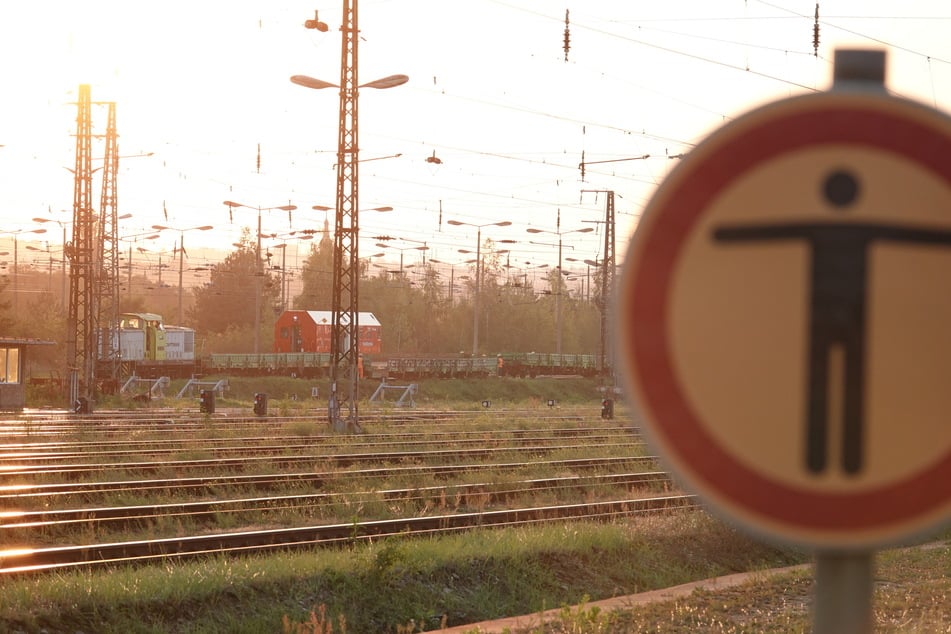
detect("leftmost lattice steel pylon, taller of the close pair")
[65,84,98,411]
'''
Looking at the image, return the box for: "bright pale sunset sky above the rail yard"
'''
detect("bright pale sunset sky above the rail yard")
[0,0,951,282]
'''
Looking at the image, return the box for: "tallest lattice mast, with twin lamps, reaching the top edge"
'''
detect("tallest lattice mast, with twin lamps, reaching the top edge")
[327,0,360,431]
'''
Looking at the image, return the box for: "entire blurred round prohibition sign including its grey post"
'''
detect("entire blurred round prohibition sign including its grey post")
[618,50,951,634]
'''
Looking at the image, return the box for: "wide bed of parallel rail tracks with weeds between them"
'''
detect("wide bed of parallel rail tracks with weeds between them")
[0,411,694,575]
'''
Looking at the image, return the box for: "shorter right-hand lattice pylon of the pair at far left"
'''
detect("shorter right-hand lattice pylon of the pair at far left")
[95,102,121,381]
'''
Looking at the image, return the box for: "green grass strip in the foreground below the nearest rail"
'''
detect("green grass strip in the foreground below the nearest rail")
[0,512,804,633]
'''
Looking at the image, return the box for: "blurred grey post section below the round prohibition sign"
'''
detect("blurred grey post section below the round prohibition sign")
[813,551,872,634]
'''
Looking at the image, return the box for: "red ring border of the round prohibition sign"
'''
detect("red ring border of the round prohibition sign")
[622,93,951,532]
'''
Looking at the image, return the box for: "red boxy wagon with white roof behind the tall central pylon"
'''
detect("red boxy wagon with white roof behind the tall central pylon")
[274,310,383,354]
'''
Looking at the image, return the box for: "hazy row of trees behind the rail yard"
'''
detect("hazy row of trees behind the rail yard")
[0,231,601,372]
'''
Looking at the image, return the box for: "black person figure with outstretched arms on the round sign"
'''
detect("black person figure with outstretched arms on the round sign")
[713,169,951,474]
